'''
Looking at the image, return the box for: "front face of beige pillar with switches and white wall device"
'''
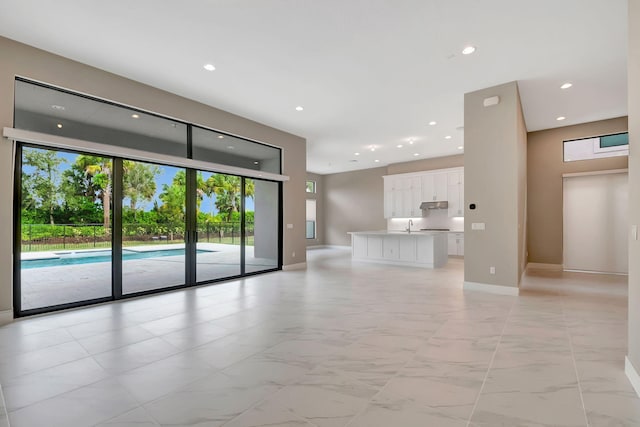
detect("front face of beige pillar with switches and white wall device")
[464,82,526,287]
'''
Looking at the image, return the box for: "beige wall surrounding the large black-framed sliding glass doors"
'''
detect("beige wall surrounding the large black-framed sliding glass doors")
[0,37,306,320]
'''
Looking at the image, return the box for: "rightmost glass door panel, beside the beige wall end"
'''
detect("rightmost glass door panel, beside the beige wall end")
[244,178,280,273]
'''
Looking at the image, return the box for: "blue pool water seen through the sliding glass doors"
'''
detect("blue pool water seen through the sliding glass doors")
[20,249,213,269]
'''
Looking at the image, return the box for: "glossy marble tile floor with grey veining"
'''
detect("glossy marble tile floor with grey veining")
[0,249,640,427]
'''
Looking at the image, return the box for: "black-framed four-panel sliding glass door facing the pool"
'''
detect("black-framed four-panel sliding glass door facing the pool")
[15,145,281,315]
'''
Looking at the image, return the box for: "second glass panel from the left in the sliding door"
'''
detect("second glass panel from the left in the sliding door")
[122,160,187,295]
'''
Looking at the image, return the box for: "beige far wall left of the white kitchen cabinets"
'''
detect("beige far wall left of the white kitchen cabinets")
[324,168,387,245]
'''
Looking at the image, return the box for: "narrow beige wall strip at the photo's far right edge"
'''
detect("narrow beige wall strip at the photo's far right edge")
[627,1,640,380]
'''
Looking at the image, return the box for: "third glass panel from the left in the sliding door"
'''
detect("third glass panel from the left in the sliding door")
[196,171,241,282]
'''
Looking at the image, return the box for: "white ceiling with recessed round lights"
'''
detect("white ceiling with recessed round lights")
[0,0,627,174]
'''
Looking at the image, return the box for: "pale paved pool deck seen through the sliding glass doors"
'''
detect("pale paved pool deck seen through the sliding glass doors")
[20,243,277,310]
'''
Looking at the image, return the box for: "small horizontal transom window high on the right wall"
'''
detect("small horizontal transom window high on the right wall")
[564,132,629,162]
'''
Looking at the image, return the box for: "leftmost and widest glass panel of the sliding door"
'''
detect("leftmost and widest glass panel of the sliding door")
[20,146,113,312]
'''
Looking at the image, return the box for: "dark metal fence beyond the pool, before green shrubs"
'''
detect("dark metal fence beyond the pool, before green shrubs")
[21,222,254,252]
